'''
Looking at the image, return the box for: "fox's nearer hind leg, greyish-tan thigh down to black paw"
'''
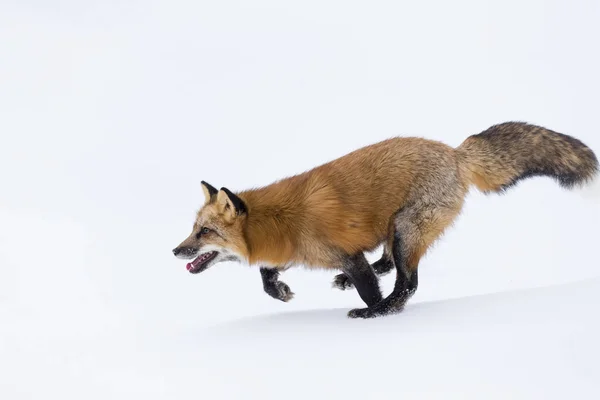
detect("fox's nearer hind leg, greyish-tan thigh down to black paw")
[348,201,462,318]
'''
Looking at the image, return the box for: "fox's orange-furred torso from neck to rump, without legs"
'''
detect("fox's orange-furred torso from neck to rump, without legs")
[238,138,453,267]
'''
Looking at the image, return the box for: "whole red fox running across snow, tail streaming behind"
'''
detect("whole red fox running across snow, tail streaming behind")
[173,122,599,318]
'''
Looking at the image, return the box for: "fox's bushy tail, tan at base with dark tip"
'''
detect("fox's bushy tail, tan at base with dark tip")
[456,122,598,192]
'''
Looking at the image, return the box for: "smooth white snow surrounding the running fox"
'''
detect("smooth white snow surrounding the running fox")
[0,0,600,400]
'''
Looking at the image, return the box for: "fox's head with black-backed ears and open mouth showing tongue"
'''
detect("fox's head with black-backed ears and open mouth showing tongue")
[173,181,248,274]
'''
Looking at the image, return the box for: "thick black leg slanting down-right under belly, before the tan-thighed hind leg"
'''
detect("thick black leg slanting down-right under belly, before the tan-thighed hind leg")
[342,253,382,307]
